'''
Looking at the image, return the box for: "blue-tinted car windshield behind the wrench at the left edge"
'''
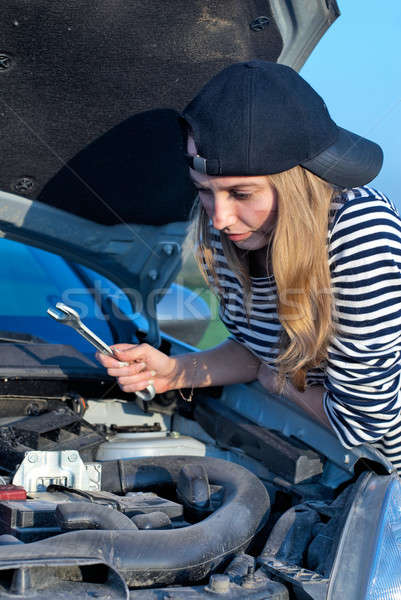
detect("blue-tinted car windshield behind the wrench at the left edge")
[0,239,113,355]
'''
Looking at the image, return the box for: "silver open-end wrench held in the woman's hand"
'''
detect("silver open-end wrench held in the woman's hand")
[47,302,155,407]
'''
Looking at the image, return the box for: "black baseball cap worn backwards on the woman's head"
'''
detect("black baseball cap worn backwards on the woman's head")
[182,60,383,187]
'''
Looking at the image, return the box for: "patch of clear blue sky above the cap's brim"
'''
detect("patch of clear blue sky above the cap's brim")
[301,0,401,210]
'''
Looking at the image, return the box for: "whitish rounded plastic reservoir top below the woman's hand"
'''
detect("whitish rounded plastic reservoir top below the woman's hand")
[96,431,206,460]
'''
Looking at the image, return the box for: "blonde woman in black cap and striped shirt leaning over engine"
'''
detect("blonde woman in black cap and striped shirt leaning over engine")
[98,61,401,469]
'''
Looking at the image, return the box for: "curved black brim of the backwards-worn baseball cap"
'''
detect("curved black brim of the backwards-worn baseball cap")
[301,127,383,188]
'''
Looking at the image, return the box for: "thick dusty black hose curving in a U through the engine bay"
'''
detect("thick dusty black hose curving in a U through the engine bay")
[0,456,270,587]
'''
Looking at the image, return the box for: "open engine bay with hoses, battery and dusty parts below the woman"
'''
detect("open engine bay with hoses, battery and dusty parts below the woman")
[0,376,368,600]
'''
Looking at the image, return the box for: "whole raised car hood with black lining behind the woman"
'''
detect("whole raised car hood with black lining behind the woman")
[0,0,339,344]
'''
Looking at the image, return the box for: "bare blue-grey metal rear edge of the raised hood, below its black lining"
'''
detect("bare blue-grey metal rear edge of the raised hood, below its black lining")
[0,192,186,347]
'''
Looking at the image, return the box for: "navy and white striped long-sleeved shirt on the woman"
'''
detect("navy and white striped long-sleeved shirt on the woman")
[206,187,401,471]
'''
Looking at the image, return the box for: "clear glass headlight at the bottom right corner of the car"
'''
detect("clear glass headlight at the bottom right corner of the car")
[327,473,401,600]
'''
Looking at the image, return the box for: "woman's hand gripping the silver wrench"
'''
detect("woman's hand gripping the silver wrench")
[96,344,176,394]
